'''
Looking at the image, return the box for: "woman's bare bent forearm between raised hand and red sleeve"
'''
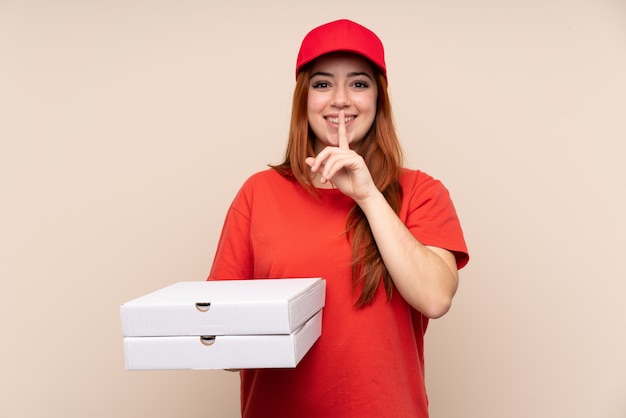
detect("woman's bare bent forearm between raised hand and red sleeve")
[357,192,458,318]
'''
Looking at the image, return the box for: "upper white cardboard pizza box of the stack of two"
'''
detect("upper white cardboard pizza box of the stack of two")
[120,278,326,337]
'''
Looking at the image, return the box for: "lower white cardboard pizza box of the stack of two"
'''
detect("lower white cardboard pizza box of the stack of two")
[124,310,322,370]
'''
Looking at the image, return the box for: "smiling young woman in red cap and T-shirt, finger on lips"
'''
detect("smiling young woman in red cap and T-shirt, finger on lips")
[209,19,469,418]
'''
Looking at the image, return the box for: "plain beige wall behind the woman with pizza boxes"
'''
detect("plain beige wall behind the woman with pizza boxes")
[0,0,626,418]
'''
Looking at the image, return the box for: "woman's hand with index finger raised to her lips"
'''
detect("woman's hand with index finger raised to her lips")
[305,110,378,203]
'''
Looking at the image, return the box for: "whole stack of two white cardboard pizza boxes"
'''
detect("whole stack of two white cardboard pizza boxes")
[120,278,326,370]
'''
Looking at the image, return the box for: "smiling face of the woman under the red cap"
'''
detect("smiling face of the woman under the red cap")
[307,53,378,153]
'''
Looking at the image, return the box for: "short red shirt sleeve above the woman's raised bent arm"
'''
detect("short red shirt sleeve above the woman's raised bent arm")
[401,171,469,269]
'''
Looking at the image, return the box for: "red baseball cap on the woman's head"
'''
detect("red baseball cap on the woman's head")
[296,19,387,78]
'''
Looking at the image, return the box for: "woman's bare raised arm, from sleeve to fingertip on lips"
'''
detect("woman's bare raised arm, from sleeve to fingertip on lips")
[306,111,458,318]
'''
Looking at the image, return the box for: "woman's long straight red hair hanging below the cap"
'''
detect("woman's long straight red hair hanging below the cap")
[271,65,403,307]
